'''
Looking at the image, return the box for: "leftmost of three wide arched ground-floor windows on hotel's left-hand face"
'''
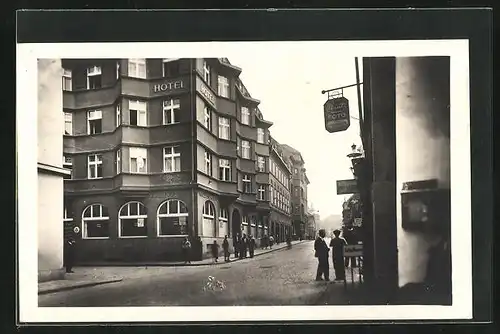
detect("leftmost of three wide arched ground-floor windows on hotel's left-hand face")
[82,204,109,239]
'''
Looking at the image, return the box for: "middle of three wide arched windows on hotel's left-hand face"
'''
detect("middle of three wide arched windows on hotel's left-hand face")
[118,202,148,238]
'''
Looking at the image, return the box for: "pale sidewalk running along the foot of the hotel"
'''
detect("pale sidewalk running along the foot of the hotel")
[38,240,307,295]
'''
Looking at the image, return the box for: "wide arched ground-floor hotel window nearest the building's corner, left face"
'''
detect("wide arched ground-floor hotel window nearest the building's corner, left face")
[157,199,188,237]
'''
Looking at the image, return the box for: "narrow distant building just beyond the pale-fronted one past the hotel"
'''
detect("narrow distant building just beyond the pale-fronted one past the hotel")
[281,144,309,238]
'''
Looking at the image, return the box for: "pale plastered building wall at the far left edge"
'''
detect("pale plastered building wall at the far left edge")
[37,59,69,281]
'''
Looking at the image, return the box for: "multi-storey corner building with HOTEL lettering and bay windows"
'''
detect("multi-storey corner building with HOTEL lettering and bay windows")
[62,58,278,264]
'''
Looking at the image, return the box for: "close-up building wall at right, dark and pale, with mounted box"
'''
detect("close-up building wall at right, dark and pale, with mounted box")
[358,57,451,304]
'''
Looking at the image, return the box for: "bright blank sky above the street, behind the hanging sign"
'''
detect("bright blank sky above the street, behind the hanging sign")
[229,53,362,218]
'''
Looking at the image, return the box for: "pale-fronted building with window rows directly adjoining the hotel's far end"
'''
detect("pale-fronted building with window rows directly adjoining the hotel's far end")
[269,137,293,242]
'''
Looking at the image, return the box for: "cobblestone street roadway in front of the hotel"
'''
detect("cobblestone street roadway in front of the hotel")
[39,242,360,307]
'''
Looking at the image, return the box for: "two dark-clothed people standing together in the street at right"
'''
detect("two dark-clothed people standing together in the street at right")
[314,229,357,281]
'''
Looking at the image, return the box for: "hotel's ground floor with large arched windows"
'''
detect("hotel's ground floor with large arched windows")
[63,188,291,265]
